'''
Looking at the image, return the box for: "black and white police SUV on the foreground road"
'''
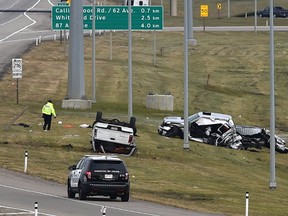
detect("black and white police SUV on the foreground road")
[67,155,130,202]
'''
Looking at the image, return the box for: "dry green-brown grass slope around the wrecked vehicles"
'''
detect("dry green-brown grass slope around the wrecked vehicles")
[0,1,288,216]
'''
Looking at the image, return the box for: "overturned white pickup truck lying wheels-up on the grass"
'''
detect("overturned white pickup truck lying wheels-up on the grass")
[91,112,137,156]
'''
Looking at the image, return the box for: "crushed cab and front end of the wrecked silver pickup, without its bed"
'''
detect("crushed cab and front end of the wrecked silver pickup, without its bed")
[158,112,242,149]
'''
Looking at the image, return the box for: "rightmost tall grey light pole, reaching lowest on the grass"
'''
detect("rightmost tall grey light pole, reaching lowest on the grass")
[269,0,276,189]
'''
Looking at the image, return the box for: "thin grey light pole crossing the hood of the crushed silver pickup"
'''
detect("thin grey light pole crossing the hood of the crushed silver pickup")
[183,0,190,150]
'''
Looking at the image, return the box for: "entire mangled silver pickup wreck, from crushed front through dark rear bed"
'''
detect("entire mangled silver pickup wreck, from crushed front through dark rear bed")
[158,112,288,153]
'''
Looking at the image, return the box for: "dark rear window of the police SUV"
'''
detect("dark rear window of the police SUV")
[91,160,126,172]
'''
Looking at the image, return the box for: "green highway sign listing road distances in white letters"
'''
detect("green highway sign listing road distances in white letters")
[51,5,163,30]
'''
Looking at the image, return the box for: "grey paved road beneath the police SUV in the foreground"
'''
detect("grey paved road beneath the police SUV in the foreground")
[0,169,223,216]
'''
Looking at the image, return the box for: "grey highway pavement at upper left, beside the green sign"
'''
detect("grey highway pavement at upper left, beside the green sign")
[0,0,59,77]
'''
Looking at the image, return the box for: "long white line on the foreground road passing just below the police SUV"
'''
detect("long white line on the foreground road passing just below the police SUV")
[0,184,161,216]
